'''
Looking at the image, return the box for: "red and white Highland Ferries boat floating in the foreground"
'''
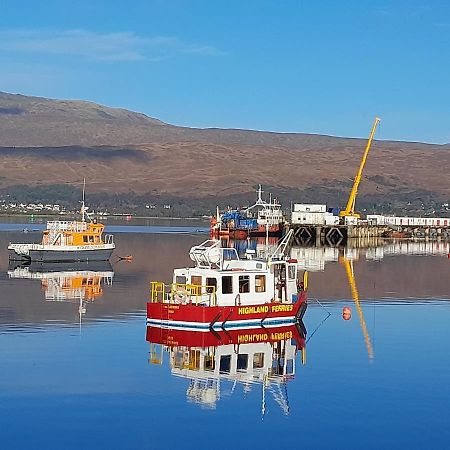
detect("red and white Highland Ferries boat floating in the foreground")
[147,234,307,331]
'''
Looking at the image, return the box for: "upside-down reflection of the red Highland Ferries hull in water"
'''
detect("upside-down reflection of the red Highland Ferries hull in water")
[146,324,305,349]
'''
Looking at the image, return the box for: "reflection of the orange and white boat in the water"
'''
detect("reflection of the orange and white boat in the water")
[8,262,114,314]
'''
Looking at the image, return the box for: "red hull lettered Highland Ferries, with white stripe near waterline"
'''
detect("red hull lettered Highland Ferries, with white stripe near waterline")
[147,291,307,329]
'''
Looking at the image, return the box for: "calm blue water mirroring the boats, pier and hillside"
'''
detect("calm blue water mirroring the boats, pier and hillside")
[0,226,450,449]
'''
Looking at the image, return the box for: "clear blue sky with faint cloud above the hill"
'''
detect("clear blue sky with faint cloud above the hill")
[0,0,450,143]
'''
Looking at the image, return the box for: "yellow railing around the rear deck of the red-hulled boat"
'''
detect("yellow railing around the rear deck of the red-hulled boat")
[150,281,217,306]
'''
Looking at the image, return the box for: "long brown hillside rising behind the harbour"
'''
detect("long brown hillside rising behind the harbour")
[0,93,450,214]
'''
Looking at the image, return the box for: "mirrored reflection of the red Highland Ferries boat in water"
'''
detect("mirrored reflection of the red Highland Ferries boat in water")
[147,322,306,415]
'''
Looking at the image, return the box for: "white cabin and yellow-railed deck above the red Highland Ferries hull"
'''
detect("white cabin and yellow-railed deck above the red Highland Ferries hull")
[152,240,303,306]
